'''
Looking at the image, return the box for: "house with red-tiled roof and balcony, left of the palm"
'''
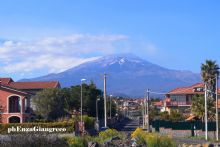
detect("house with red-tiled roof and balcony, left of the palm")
[164,83,220,115]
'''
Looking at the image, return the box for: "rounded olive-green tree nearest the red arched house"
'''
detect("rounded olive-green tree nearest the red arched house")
[33,88,67,120]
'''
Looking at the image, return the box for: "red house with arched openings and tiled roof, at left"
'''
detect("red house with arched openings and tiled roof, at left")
[0,78,60,123]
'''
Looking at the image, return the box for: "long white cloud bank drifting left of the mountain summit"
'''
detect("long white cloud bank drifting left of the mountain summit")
[0,34,128,75]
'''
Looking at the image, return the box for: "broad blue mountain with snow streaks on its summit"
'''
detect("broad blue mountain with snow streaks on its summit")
[21,54,201,97]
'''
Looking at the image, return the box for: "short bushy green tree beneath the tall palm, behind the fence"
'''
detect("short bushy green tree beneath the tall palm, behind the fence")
[191,94,215,121]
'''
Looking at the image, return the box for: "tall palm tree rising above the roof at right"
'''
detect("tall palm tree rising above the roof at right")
[201,60,219,98]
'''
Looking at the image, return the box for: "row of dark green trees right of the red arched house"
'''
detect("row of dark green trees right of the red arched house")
[33,82,115,120]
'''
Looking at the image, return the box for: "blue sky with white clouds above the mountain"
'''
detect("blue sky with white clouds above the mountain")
[0,0,220,80]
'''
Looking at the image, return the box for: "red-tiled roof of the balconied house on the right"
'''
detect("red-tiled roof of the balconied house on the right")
[167,83,220,94]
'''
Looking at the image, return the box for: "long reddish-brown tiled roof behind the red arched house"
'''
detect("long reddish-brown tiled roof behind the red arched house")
[9,81,60,89]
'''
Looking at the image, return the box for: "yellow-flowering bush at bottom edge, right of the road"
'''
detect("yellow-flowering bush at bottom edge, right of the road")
[131,128,176,147]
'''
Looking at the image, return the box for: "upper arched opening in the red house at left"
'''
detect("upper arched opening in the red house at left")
[8,96,21,113]
